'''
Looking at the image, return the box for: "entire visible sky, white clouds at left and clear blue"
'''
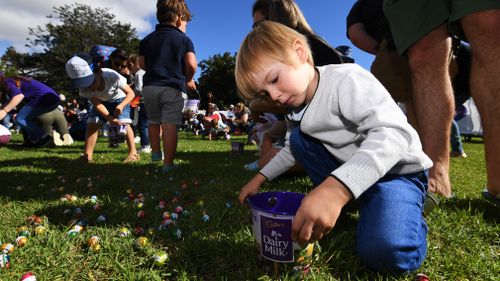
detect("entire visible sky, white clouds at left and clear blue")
[0,0,373,78]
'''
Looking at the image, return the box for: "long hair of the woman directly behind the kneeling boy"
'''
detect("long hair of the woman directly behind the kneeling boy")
[252,0,314,35]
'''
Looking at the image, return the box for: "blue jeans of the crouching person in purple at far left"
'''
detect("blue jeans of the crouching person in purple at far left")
[16,104,58,139]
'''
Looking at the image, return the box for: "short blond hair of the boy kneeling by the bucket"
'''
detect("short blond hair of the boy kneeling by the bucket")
[234,21,314,100]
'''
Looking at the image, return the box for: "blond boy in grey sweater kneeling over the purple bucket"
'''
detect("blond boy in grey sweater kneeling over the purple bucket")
[235,21,432,273]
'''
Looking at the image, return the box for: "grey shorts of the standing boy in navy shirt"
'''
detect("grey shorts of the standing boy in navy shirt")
[142,86,187,125]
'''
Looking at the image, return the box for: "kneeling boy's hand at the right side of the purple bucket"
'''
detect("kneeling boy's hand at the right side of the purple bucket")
[292,177,352,244]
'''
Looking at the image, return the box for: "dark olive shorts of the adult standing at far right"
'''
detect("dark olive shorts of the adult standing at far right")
[384,0,500,54]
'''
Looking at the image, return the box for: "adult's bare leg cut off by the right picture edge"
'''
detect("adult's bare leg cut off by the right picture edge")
[462,9,500,195]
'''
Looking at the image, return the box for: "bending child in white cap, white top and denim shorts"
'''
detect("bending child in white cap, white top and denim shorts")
[66,56,140,163]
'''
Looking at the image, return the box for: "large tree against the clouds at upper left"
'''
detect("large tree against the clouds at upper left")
[2,4,139,92]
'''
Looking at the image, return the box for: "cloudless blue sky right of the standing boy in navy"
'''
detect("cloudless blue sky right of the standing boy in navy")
[187,0,373,77]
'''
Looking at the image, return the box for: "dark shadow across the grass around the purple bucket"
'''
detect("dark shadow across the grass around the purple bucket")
[0,139,398,280]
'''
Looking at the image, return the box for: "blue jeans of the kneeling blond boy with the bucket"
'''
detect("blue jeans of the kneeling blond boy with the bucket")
[290,127,427,273]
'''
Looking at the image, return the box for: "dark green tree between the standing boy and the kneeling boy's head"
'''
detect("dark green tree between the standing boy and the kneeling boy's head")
[198,52,241,108]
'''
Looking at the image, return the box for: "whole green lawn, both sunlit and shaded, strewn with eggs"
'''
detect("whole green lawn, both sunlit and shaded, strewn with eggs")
[0,133,500,280]
